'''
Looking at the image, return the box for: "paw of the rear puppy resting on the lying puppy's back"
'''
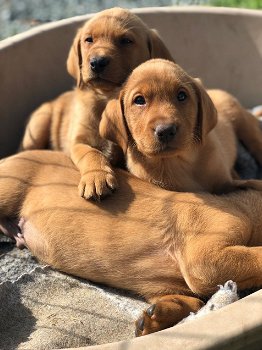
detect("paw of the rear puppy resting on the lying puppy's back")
[78,169,118,201]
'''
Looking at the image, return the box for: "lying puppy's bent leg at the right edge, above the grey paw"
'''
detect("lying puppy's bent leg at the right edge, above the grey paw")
[185,243,262,296]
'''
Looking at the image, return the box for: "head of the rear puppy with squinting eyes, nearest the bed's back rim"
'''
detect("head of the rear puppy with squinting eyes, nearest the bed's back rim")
[67,8,172,89]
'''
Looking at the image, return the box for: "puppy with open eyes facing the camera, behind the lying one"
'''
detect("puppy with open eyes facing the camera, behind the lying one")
[100,59,262,193]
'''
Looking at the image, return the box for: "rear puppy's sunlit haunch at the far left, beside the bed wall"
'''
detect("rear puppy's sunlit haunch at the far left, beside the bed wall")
[20,102,52,150]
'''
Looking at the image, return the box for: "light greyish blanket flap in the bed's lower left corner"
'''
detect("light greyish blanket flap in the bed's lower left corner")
[0,267,146,350]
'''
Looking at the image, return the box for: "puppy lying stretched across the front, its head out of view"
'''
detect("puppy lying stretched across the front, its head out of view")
[0,151,262,335]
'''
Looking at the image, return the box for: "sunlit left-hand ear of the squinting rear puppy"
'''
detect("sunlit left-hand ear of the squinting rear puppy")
[67,29,83,87]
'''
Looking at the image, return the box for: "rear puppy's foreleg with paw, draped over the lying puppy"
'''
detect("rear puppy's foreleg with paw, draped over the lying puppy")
[71,143,117,200]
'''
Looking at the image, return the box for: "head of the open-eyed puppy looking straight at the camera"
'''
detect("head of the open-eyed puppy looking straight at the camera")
[100,59,217,157]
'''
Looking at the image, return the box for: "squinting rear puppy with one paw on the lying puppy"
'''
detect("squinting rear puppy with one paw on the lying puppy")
[21,8,172,199]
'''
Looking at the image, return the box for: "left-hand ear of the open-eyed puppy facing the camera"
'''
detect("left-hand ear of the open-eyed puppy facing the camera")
[99,97,128,153]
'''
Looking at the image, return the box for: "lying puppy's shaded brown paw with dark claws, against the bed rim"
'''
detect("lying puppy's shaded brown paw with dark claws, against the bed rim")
[136,295,204,336]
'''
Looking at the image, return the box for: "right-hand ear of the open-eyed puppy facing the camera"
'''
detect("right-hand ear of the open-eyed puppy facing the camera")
[194,79,217,142]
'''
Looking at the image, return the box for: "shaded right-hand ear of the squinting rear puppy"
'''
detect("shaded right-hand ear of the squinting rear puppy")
[149,29,175,62]
